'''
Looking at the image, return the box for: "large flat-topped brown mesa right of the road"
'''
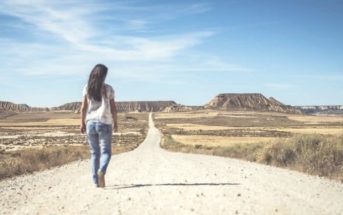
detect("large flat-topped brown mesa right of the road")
[205,93,301,113]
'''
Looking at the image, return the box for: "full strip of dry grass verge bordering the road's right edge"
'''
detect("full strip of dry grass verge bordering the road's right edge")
[161,135,343,182]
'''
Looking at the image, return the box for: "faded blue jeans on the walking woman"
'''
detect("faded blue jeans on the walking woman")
[86,121,112,184]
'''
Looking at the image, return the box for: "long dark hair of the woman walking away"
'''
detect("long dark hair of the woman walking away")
[87,64,108,101]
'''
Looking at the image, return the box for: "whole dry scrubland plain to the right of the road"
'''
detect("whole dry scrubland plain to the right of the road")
[155,110,343,181]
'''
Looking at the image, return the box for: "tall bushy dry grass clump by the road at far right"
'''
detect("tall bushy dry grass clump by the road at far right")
[256,135,343,182]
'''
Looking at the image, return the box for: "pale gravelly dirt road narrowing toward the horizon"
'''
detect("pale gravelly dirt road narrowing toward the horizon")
[0,113,343,215]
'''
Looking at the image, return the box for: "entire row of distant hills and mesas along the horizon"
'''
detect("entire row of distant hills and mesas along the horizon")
[0,93,343,114]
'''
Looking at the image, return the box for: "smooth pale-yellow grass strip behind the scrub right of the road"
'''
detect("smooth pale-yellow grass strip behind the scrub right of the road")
[172,135,277,147]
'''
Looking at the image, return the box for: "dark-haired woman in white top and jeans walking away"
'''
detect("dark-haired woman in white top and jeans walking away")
[80,64,118,187]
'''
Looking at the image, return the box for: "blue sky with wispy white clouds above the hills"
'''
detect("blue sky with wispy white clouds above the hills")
[0,0,343,107]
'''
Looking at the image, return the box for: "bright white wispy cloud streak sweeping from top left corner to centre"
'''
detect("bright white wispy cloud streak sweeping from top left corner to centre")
[0,1,218,60]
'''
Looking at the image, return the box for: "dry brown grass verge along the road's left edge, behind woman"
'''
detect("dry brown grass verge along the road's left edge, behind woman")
[0,144,138,180]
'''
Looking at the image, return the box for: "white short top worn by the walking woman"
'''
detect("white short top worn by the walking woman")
[82,84,114,125]
